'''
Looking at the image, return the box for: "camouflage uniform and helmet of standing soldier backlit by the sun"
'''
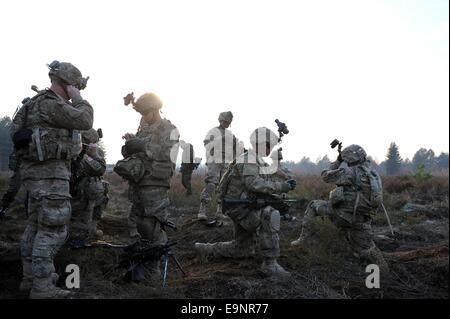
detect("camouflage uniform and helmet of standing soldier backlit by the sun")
[125,93,179,250]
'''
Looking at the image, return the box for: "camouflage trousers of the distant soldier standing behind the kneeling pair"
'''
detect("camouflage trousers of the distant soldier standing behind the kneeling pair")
[199,163,227,219]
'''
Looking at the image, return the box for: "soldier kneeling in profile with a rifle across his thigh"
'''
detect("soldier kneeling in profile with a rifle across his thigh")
[195,127,296,277]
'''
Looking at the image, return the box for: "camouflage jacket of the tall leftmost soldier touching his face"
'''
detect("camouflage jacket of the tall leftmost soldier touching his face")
[11,90,93,180]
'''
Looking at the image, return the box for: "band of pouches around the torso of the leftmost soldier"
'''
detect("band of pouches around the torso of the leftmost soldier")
[24,128,82,162]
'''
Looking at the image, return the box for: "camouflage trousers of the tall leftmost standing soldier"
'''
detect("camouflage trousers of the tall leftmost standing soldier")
[20,179,71,290]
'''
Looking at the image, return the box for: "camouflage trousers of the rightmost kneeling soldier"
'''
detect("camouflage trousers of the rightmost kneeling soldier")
[301,200,384,263]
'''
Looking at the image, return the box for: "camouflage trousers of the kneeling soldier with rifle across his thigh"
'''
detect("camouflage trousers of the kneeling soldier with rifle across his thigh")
[203,206,280,258]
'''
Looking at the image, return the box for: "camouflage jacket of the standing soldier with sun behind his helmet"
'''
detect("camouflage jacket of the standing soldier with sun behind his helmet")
[136,119,179,188]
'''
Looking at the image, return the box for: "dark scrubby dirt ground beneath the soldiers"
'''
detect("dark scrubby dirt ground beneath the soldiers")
[0,172,449,299]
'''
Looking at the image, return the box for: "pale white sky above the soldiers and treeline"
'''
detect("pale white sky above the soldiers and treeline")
[0,0,449,163]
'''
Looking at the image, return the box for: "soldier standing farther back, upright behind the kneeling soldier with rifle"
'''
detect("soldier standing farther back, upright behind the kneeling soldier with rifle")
[197,112,243,225]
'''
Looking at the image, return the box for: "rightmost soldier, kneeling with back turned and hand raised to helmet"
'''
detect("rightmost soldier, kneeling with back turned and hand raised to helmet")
[291,145,388,272]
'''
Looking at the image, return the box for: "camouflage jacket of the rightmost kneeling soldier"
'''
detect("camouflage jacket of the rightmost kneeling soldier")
[321,161,373,215]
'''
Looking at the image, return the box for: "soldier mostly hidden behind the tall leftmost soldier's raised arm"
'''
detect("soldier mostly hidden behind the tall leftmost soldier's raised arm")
[70,129,109,244]
